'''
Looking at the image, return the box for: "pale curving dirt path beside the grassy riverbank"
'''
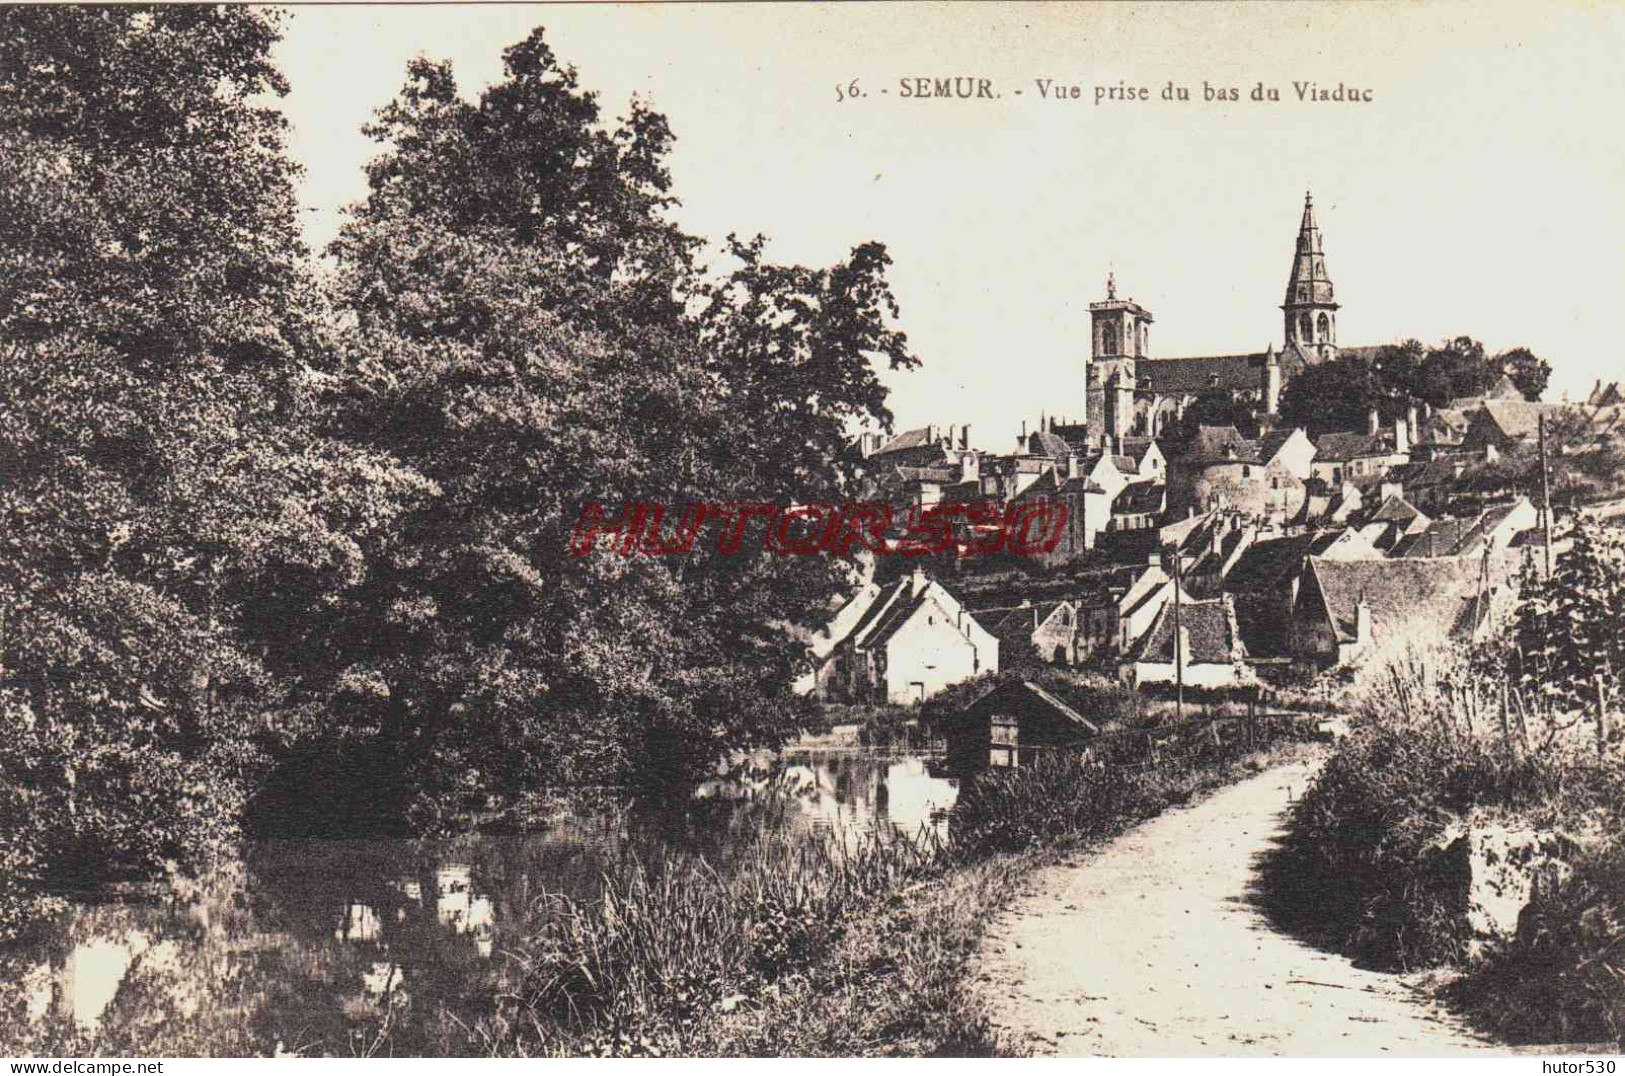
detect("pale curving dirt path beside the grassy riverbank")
[972,764,1495,1056]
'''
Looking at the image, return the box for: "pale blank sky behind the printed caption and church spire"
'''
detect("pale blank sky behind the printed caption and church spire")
[278,2,1625,450]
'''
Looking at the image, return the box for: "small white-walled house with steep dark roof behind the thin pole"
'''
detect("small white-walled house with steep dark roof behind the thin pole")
[1120,595,1255,688]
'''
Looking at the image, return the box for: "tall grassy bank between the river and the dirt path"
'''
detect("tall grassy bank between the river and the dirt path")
[447,725,1302,1056]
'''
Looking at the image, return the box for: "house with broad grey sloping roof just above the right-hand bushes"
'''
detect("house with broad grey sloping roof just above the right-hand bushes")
[1287,556,1516,665]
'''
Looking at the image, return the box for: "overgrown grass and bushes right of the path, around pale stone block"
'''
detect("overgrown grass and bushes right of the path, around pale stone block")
[1263,652,1625,1045]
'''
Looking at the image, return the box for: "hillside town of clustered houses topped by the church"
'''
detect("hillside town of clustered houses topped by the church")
[812,195,1625,715]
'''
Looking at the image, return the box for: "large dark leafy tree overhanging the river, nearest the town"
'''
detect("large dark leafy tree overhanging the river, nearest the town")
[332,31,915,788]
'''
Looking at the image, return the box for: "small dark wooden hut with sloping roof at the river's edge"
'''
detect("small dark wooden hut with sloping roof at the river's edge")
[943,678,1100,779]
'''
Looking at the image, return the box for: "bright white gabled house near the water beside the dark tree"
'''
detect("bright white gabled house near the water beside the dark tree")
[826,567,999,704]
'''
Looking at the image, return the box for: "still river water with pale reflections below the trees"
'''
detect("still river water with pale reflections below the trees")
[0,753,956,1056]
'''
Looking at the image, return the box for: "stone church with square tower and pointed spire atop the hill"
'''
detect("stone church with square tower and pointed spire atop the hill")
[1055,195,1380,445]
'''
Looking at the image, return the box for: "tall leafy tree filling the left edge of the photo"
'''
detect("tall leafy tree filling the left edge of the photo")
[0,7,427,931]
